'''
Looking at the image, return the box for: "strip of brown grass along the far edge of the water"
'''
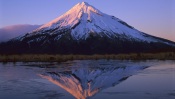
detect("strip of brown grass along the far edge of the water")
[0,52,175,62]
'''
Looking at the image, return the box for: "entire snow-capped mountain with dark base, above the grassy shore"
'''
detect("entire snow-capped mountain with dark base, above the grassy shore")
[0,2,175,54]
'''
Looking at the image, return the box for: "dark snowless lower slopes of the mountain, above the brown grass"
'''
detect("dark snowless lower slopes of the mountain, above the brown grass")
[0,32,175,55]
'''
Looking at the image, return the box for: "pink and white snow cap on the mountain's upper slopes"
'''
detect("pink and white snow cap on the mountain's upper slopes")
[26,2,160,42]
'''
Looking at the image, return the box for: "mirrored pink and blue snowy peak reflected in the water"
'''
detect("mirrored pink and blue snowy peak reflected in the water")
[40,60,147,99]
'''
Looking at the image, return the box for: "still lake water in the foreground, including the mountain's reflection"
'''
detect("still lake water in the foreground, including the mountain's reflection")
[0,60,175,99]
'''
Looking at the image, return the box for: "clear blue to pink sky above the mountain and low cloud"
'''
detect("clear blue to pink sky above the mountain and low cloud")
[0,0,175,41]
